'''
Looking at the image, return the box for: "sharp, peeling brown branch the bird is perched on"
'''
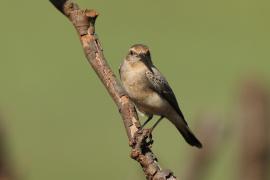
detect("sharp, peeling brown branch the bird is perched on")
[50,0,176,180]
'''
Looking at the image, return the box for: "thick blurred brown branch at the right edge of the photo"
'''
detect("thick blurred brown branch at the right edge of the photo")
[239,78,270,180]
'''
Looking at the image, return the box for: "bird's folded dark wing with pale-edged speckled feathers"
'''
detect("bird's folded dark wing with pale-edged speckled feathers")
[146,67,187,124]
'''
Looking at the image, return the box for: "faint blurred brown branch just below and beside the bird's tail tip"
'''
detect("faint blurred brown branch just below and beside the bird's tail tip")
[185,111,224,180]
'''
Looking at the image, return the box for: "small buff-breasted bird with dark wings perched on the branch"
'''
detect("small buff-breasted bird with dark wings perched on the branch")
[119,44,202,148]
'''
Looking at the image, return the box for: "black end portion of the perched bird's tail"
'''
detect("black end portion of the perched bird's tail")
[177,126,202,148]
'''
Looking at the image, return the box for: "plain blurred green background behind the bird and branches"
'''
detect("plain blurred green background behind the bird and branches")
[0,0,270,180]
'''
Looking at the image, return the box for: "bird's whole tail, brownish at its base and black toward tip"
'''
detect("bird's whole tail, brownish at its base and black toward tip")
[172,118,202,148]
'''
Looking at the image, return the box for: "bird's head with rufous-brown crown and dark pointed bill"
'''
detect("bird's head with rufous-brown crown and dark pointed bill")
[126,44,153,69]
